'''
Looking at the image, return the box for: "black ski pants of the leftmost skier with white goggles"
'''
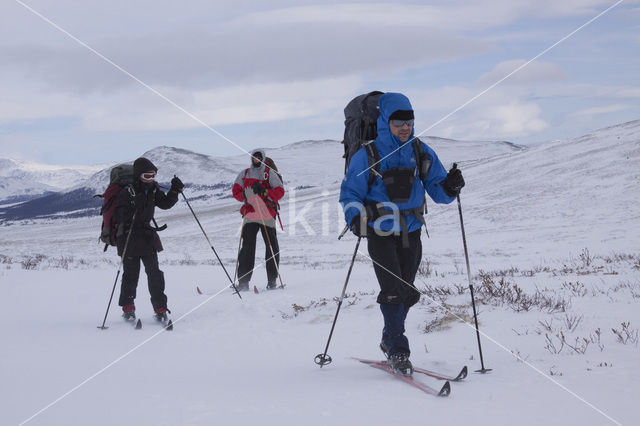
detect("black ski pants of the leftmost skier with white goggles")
[119,253,167,310]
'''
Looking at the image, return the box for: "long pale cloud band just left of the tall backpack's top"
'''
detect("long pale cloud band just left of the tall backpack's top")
[77,77,361,131]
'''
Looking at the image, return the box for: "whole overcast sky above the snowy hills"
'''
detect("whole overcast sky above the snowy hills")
[0,0,640,164]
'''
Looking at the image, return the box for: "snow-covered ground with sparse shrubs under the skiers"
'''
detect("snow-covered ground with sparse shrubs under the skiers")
[0,121,640,425]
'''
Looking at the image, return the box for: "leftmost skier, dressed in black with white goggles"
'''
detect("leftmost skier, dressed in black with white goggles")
[115,157,184,320]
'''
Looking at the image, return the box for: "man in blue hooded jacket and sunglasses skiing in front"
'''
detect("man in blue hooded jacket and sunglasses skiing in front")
[340,93,464,375]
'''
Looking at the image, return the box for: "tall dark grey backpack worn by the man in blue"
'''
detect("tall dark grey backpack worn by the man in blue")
[342,90,431,185]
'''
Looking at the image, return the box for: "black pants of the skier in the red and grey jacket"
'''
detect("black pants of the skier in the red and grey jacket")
[238,222,280,285]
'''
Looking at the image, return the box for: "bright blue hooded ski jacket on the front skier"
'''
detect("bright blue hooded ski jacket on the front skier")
[340,93,455,233]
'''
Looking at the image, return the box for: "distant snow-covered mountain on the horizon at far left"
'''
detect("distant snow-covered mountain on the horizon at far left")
[0,158,104,205]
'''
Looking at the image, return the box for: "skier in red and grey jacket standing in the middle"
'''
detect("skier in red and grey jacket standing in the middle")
[232,149,284,291]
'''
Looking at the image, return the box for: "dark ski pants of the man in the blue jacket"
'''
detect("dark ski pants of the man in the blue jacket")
[367,229,422,355]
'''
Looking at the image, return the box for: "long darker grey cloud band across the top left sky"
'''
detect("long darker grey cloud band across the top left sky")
[0,4,491,93]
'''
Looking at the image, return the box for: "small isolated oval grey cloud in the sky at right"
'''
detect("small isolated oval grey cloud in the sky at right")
[478,59,567,85]
